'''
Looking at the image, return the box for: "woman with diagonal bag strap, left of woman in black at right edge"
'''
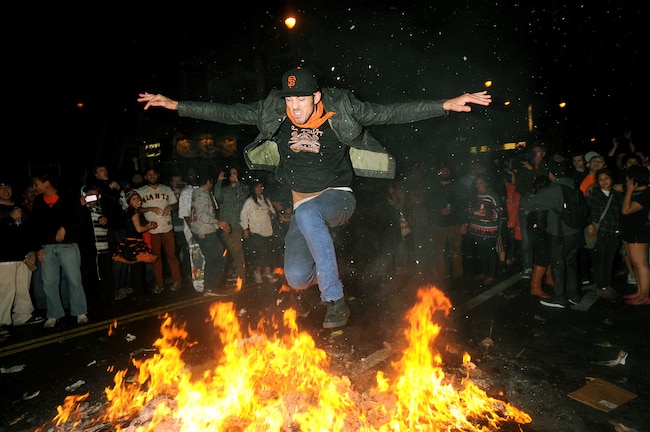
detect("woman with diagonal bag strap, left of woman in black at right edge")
[587,168,623,299]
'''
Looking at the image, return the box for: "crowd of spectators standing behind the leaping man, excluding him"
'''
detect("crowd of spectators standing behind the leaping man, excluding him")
[0,132,650,337]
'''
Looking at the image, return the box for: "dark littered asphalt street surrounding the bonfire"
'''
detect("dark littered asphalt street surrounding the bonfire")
[0,269,650,432]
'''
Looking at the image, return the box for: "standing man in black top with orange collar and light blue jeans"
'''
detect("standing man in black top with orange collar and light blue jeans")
[32,174,88,328]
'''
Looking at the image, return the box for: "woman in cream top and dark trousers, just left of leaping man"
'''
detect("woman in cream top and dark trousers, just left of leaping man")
[239,180,278,284]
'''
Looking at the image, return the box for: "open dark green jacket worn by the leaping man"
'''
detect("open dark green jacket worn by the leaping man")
[178,88,447,178]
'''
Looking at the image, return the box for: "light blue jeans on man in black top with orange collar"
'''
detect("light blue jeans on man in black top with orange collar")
[39,243,87,318]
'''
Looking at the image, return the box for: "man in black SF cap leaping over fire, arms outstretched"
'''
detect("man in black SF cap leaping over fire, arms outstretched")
[137,67,492,328]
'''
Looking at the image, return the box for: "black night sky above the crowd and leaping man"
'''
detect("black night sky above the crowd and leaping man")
[10,0,648,182]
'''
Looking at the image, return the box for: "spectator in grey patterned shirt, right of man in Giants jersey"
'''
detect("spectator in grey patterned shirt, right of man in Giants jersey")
[190,171,230,296]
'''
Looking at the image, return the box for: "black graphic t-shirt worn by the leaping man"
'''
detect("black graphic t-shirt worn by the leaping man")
[274,119,354,193]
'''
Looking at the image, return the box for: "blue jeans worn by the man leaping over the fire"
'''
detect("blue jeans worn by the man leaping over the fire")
[284,189,356,302]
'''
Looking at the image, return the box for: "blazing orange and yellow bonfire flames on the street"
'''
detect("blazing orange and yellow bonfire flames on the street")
[38,286,532,432]
